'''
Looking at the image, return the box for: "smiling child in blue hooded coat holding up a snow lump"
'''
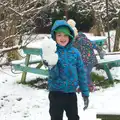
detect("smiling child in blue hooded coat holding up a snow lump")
[44,20,89,120]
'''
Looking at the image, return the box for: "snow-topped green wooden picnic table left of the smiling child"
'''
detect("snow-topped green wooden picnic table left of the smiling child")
[12,47,48,84]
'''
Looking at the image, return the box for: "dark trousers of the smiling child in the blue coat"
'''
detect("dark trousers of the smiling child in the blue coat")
[49,91,79,120]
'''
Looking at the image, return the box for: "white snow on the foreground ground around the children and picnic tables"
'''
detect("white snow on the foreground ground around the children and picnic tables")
[0,31,120,120]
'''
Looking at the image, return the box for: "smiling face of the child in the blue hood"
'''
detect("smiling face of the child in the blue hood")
[56,32,70,46]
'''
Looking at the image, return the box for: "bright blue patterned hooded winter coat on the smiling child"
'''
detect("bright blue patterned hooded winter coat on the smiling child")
[48,20,89,96]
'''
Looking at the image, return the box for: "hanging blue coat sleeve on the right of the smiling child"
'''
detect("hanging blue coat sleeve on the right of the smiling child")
[77,53,89,96]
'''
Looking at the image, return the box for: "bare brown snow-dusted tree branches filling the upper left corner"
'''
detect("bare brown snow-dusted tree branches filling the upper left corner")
[0,0,57,63]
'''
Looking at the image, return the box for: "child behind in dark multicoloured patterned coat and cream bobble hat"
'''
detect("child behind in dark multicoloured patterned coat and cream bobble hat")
[67,19,104,92]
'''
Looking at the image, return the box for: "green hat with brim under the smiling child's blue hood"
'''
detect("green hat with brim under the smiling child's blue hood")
[55,26,73,39]
